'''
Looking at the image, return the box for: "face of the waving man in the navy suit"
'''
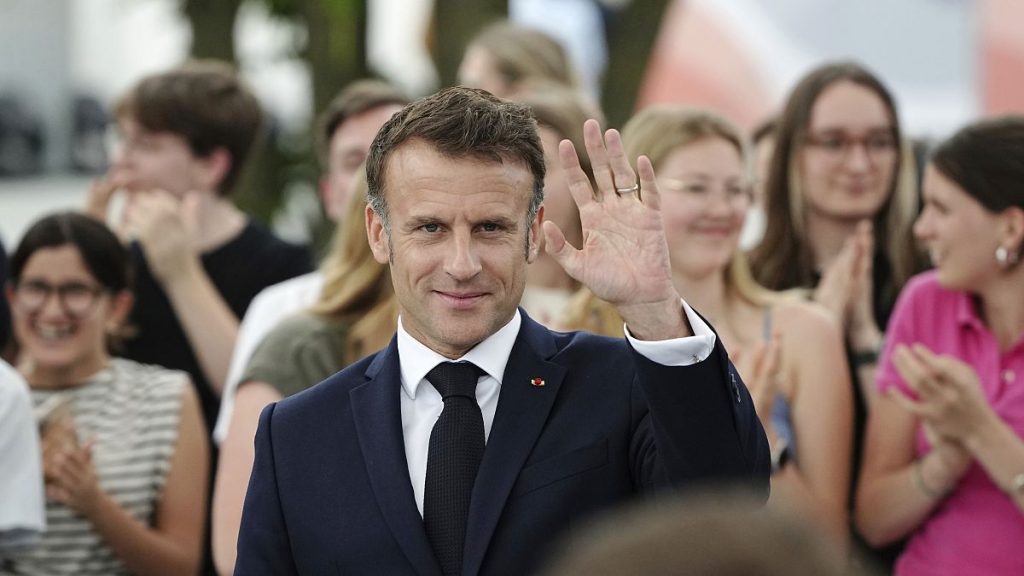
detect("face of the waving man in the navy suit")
[367,140,543,359]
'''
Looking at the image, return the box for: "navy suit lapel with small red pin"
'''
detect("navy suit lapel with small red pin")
[462,308,565,574]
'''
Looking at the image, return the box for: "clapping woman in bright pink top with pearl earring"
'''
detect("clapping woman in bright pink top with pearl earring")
[855,116,1024,576]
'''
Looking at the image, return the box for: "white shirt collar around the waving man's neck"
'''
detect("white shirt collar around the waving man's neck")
[397,308,522,399]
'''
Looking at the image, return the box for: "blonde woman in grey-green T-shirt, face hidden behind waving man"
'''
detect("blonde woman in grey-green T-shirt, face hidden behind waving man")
[213,170,398,574]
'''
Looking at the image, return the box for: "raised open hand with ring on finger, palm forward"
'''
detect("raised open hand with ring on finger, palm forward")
[544,120,691,339]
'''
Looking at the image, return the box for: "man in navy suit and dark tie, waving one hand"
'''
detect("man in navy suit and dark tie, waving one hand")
[236,88,769,576]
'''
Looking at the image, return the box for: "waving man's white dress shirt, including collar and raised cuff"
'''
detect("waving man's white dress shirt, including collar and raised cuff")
[398,301,715,516]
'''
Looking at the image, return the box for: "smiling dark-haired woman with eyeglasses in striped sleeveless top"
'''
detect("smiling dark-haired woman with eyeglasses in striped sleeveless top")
[0,213,209,575]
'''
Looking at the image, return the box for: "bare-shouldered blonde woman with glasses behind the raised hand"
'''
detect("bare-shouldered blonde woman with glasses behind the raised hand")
[567,107,851,542]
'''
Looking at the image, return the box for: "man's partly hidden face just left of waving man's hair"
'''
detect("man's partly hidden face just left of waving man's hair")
[321,104,401,223]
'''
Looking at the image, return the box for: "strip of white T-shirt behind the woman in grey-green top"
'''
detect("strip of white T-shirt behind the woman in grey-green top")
[213,271,324,444]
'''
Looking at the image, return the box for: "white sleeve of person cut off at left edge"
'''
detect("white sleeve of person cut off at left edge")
[0,360,46,550]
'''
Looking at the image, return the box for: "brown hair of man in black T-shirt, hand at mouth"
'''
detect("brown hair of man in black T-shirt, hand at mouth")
[115,60,262,195]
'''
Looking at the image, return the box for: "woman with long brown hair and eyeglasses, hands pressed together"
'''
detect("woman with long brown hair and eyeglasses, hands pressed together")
[750,61,924,562]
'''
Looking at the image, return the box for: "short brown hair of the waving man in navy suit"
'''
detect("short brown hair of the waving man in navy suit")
[367,86,545,230]
